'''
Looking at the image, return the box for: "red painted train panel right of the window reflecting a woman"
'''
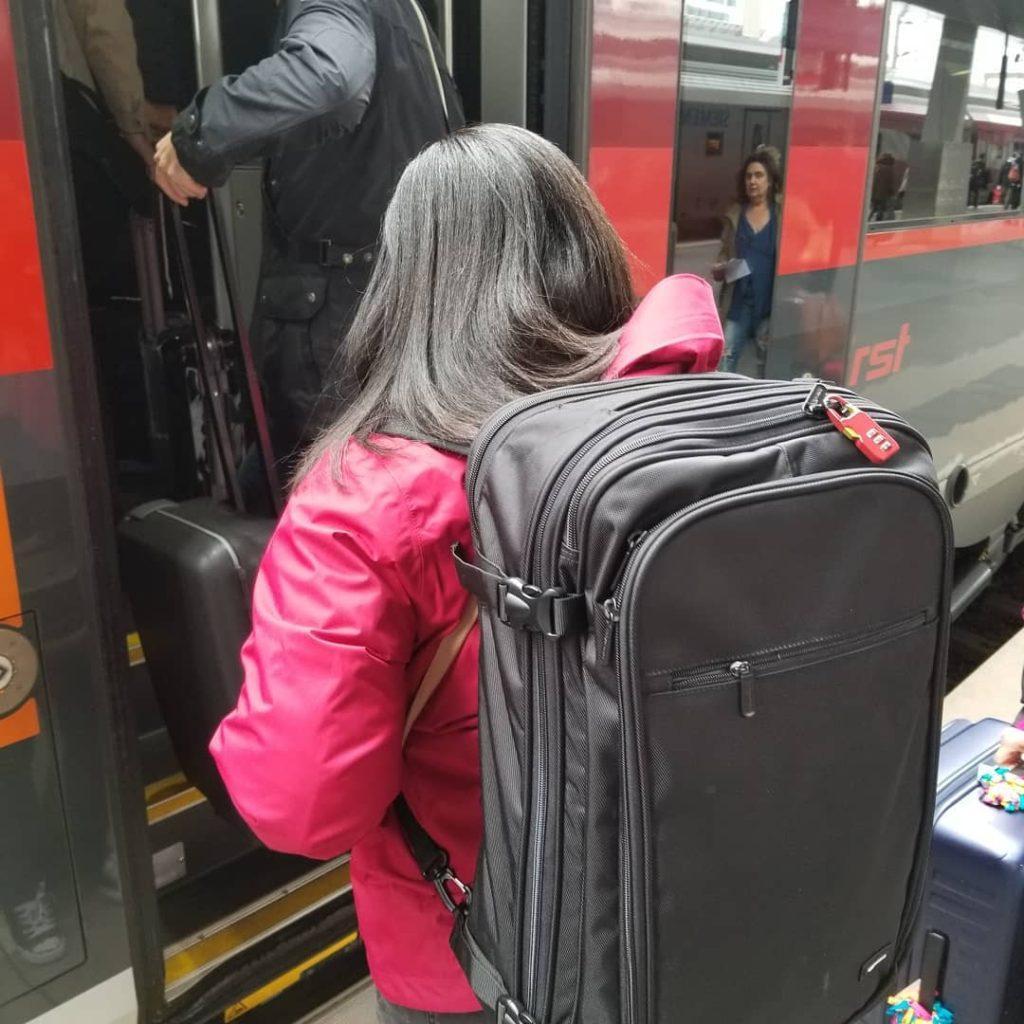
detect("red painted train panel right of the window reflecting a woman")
[778,0,885,274]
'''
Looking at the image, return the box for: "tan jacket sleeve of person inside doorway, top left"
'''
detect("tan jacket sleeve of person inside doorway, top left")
[65,0,148,135]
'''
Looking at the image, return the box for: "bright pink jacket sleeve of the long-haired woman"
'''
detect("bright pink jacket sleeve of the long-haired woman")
[210,454,419,859]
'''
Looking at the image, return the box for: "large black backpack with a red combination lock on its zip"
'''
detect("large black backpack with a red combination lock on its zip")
[398,374,952,1024]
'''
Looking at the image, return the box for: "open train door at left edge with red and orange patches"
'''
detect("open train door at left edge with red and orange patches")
[0,0,139,1024]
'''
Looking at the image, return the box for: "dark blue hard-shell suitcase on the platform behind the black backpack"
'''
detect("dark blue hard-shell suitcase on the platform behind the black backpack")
[858,719,1024,1024]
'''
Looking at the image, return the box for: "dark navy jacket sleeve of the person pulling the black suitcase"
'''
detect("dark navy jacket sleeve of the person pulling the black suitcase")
[172,0,376,185]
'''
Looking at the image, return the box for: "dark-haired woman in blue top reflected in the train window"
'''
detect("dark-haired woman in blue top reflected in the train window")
[712,145,782,377]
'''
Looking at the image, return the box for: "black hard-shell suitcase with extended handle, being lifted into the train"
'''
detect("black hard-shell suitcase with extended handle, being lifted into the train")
[119,204,280,817]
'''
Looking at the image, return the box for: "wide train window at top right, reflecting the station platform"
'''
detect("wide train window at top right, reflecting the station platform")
[868,0,1024,229]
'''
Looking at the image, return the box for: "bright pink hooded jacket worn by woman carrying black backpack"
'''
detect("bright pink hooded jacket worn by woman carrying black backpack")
[210,276,722,1013]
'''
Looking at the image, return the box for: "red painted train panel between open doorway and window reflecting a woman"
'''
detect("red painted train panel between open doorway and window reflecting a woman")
[589,0,683,295]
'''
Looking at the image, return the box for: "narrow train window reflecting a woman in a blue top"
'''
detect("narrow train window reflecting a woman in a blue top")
[675,0,796,376]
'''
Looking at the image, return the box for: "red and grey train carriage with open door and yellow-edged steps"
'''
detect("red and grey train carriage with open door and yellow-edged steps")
[0,0,1024,1024]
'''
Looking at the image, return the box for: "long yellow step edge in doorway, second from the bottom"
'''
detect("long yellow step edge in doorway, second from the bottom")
[164,863,350,987]
